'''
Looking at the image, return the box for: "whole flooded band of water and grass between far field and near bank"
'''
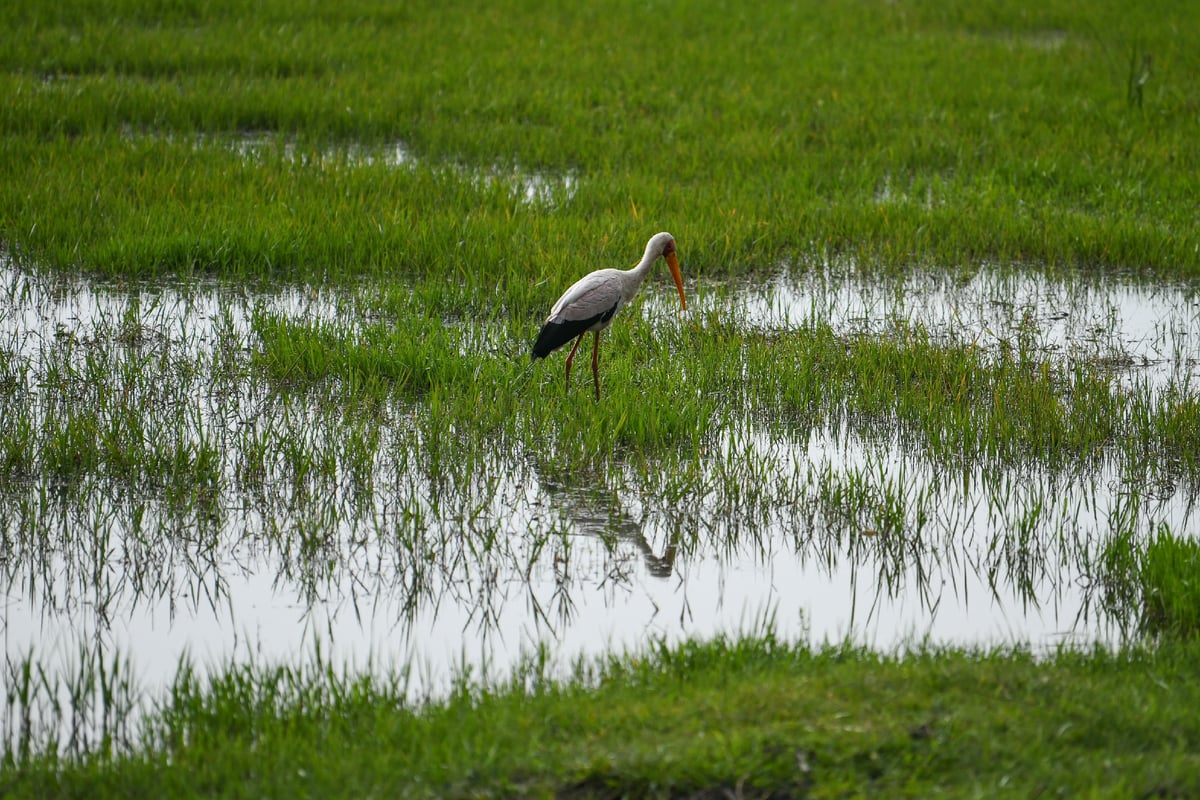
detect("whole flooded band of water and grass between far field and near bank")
[0,253,1200,753]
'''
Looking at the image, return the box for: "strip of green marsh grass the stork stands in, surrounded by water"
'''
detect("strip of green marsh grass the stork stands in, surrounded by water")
[243,299,1200,485]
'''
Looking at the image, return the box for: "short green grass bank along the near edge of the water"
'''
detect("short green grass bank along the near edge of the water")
[0,633,1200,798]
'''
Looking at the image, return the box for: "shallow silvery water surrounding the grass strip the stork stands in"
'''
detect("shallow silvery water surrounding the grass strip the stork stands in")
[0,264,1200,748]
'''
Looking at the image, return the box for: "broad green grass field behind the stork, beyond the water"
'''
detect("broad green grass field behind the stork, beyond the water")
[0,0,1200,281]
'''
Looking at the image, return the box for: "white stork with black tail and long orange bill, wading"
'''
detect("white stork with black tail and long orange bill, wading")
[533,231,688,399]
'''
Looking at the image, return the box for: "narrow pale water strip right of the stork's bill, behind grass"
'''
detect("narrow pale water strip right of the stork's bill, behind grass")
[646,265,1200,387]
